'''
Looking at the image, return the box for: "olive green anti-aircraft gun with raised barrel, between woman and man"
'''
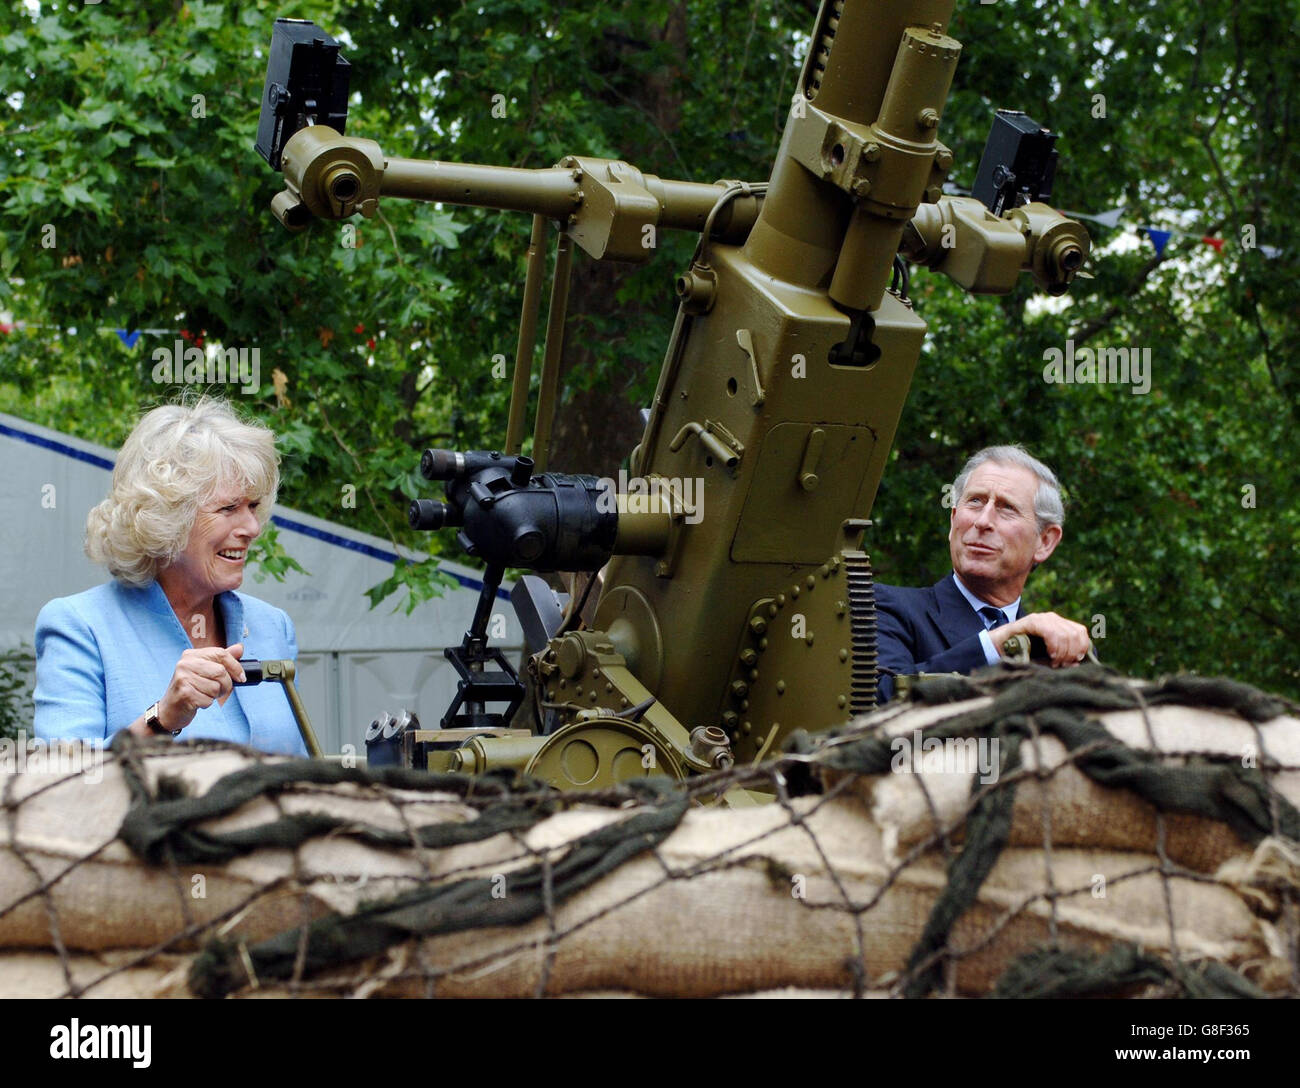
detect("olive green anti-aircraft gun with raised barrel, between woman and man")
[256,0,1089,803]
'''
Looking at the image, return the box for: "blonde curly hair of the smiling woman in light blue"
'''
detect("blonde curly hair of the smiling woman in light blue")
[86,396,280,586]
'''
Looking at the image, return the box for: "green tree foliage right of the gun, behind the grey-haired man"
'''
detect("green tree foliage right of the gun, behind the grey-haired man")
[874,0,1300,694]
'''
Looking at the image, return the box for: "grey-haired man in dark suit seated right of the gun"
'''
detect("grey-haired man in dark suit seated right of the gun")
[876,446,1092,702]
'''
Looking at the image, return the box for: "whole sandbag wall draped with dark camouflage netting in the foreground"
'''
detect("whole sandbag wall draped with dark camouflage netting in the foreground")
[0,657,1300,997]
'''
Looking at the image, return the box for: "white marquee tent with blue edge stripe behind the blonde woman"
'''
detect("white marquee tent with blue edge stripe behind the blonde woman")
[0,413,523,754]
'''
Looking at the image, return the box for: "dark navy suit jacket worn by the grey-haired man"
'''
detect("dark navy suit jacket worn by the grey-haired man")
[875,575,988,703]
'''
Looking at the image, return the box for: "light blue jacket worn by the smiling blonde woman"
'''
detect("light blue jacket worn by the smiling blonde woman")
[35,581,307,755]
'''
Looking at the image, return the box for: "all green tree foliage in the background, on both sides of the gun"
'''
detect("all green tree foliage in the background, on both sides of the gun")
[0,0,1300,694]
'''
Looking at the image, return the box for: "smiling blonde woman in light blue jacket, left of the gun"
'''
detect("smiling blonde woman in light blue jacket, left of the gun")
[35,396,306,755]
